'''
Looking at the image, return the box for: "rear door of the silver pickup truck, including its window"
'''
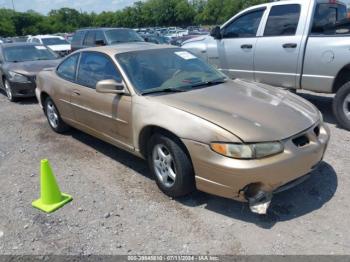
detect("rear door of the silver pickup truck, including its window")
[254,3,307,88]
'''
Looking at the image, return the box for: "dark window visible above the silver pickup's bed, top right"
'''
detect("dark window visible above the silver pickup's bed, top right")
[311,4,350,35]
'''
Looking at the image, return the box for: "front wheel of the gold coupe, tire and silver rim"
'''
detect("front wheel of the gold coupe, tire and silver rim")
[147,134,195,198]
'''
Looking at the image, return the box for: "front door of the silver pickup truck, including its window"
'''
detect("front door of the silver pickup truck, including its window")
[217,8,265,80]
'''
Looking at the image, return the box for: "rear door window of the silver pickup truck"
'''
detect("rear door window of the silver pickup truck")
[264,4,300,36]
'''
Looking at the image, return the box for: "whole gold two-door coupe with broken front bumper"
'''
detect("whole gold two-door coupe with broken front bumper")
[36,43,329,213]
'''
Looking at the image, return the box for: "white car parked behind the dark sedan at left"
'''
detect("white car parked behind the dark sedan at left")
[27,35,71,57]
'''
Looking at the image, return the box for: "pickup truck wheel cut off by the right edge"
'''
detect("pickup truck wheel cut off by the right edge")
[333,82,350,131]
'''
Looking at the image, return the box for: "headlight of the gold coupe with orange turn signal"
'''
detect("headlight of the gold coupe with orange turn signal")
[210,142,284,159]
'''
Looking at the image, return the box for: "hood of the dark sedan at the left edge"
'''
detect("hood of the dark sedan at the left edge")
[7,59,61,75]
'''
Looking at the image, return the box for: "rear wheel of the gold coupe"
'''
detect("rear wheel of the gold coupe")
[44,97,69,133]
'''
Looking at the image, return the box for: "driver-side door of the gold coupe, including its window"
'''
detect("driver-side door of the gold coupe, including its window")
[71,51,132,146]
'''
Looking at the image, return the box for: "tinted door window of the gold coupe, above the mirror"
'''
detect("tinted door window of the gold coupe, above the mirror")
[78,52,122,88]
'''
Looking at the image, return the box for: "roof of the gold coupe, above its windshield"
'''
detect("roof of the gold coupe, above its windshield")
[79,42,179,56]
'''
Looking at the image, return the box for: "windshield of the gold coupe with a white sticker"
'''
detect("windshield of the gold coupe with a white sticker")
[116,48,226,94]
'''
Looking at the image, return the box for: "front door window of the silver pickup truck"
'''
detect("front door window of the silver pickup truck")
[222,9,265,38]
